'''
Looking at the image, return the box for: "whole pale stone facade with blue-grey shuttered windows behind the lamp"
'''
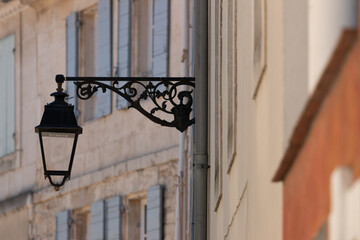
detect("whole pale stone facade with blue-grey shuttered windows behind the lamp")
[0,0,191,240]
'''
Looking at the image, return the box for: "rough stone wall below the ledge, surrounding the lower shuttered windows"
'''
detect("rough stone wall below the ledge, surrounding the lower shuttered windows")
[32,155,177,240]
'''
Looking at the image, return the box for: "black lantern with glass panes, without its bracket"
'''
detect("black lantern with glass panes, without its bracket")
[35,76,82,191]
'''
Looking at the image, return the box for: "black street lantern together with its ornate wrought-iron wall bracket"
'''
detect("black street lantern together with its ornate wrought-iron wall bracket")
[35,75,195,191]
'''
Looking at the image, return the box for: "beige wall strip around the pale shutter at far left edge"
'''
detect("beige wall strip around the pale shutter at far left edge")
[0,1,39,199]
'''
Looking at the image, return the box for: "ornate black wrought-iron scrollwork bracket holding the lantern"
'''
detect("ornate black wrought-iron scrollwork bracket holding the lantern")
[59,75,195,132]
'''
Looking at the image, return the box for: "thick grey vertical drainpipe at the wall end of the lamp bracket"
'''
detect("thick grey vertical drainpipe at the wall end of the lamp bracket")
[193,0,208,240]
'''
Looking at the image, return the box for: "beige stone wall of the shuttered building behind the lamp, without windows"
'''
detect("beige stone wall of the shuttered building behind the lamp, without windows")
[0,0,186,239]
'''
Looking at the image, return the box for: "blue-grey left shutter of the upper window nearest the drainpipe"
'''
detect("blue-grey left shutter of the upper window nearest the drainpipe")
[116,0,131,109]
